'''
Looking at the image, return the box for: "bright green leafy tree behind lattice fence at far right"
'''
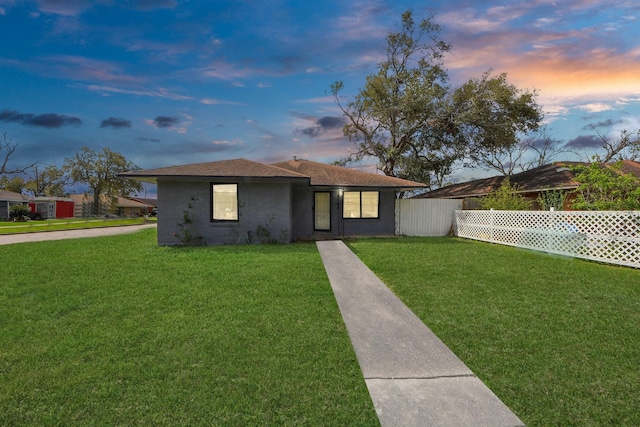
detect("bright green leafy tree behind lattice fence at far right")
[570,161,640,211]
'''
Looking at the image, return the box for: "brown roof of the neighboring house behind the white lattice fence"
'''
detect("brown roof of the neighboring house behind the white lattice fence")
[416,162,583,199]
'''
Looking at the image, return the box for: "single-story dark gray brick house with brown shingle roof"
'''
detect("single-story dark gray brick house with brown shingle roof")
[122,158,425,245]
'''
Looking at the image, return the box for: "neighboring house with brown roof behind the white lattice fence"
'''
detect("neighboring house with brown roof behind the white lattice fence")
[415,160,640,209]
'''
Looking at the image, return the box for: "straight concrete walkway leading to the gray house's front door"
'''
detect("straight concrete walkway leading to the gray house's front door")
[317,240,524,427]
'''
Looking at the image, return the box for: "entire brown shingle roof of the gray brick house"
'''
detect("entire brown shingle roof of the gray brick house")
[122,159,426,189]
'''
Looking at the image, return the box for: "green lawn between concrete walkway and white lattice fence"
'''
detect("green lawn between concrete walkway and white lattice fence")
[350,238,640,426]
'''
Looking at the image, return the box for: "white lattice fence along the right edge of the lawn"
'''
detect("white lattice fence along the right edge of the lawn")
[454,210,640,268]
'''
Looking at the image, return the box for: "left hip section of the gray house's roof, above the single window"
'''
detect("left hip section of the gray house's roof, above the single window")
[122,159,308,183]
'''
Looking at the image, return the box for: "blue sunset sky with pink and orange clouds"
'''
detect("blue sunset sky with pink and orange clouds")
[0,0,640,188]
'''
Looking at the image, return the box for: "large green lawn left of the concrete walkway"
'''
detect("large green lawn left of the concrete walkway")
[0,230,378,426]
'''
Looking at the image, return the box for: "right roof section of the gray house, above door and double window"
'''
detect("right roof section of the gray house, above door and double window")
[272,160,426,189]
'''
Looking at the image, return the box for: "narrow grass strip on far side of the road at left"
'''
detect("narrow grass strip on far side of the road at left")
[0,218,155,235]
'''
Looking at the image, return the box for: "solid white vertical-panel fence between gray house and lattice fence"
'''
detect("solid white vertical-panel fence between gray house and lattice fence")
[396,199,462,236]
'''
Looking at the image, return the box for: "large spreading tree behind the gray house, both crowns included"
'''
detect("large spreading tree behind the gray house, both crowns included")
[331,11,541,186]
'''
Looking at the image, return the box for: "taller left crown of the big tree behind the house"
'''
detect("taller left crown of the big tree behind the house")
[331,11,450,187]
